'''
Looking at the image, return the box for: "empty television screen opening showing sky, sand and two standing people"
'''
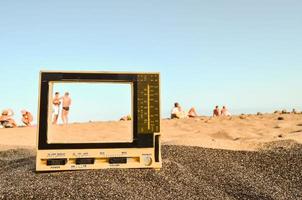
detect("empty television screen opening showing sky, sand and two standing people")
[47,82,133,143]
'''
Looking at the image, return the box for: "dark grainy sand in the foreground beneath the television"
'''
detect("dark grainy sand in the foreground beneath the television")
[0,144,302,200]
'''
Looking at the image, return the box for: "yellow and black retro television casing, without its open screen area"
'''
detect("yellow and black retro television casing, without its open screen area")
[36,71,162,171]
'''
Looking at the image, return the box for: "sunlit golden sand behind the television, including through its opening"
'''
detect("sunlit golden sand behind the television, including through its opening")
[0,114,302,150]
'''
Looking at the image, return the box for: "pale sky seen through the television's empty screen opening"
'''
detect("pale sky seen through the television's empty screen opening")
[53,83,132,123]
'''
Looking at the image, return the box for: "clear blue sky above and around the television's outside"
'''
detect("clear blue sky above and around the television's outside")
[0,0,302,123]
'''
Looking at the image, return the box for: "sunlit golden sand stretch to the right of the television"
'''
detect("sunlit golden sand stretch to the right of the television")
[162,114,302,151]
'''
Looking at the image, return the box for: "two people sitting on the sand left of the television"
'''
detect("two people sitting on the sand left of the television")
[0,109,33,128]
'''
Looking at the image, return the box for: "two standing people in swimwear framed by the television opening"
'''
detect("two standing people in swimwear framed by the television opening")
[52,92,71,124]
